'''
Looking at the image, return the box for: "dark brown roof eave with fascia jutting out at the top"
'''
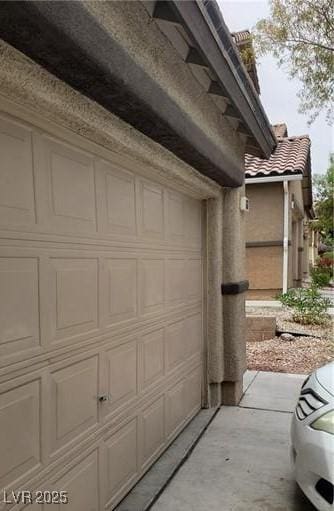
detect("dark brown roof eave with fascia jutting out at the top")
[150,0,276,158]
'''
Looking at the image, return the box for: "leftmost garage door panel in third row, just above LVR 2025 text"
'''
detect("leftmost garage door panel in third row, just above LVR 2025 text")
[0,379,42,488]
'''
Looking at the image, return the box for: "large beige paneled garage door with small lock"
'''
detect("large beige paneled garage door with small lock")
[0,109,203,511]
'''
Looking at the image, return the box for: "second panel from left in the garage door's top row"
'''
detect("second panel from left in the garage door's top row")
[35,136,97,233]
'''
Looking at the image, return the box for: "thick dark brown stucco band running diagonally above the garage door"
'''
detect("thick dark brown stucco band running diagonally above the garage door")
[0,0,244,187]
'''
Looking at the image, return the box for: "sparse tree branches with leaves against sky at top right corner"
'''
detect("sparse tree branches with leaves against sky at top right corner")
[253,0,334,124]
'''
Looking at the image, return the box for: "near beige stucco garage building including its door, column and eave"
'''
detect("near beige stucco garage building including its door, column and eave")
[0,1,276,511]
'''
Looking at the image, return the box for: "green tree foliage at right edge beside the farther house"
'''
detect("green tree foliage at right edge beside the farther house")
[313,153,334,246]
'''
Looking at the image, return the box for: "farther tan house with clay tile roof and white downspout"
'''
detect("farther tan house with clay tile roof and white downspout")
[245,124,315,300]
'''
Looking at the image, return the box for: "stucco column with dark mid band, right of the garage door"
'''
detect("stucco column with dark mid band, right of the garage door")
[222,187,246,405]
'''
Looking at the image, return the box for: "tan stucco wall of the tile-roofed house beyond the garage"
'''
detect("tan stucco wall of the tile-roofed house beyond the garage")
[246,181,308,299]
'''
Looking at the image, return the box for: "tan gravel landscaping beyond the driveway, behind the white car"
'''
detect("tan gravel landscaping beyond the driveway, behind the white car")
[246,307,334,374]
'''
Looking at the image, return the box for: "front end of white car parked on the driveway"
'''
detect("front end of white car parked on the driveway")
[291,362,334,511]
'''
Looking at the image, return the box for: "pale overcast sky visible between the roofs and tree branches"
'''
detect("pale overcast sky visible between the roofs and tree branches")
[218,0,334,174]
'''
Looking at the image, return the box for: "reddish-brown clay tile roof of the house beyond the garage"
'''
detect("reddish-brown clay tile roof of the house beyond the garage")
[245,135,311,178]
